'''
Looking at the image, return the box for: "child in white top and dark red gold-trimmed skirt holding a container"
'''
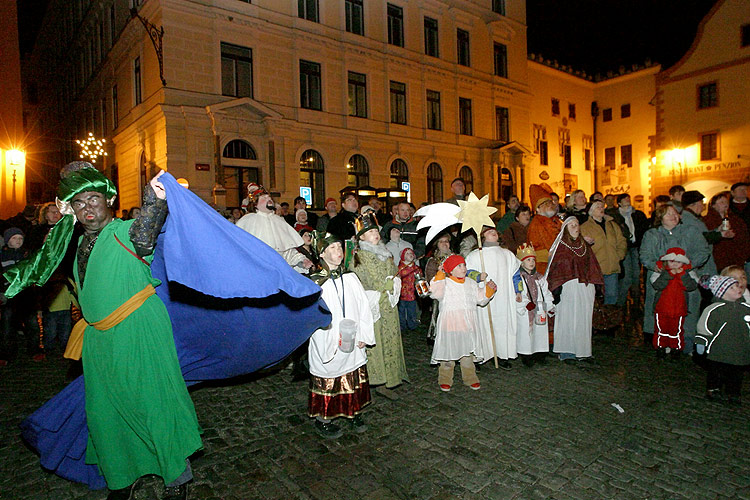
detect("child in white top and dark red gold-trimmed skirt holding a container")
[308,234,375,439]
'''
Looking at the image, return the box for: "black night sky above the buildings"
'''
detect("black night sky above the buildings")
[18,0,714,74]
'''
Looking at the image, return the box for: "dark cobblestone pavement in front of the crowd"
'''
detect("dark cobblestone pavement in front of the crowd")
[0,328,750,500]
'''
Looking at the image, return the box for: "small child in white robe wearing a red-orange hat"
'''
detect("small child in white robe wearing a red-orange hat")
[430,255,497,392]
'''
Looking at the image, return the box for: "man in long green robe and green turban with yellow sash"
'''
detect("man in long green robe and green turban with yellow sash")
[6,162,202,500]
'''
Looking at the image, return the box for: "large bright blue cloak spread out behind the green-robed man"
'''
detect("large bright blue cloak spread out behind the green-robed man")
[21,173,331,489]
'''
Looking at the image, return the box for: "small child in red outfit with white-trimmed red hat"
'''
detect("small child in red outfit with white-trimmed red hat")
[651,247,698,359]
